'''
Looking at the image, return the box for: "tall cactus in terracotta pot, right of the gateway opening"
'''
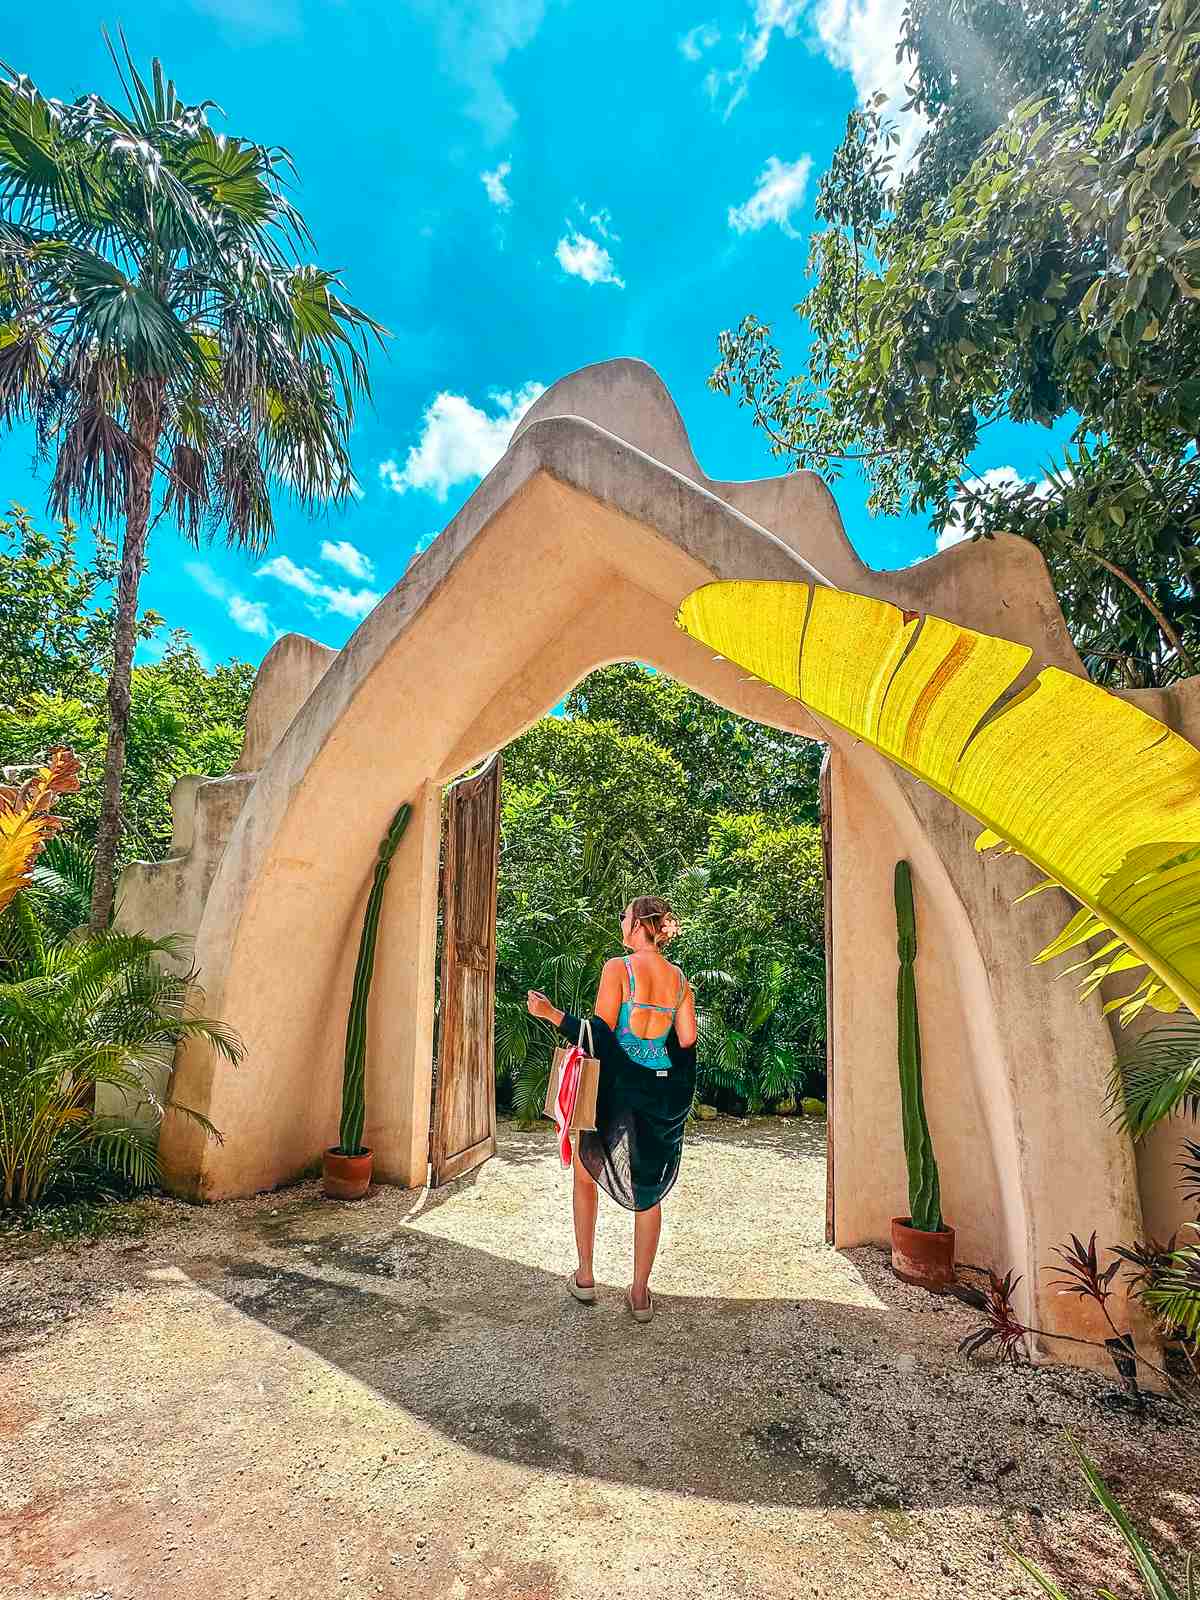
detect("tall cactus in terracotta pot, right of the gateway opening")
[891,861,954,1290]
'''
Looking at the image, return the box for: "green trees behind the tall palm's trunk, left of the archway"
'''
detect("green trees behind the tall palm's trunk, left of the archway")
[0,506,254,864]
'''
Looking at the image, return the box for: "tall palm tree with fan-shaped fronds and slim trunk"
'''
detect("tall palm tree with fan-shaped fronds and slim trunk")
[0,35,384,928]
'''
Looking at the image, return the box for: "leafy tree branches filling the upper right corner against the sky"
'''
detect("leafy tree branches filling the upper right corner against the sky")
[712,0,1200,686]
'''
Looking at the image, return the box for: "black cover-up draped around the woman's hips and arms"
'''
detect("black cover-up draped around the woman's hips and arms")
[558,1013,696,1211]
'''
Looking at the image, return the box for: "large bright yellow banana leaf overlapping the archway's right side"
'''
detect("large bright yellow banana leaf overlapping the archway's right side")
[677,582,1200,1014]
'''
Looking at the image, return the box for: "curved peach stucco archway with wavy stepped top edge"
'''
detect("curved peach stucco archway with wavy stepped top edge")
[123,362,1200,1376]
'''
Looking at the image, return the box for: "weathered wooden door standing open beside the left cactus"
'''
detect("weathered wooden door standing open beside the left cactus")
[429,755,502,1187]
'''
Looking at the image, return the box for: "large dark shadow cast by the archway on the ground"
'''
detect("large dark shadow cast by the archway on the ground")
[157,1179,1184,1548]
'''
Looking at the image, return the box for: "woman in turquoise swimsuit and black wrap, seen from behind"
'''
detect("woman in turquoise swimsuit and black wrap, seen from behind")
[528,894,696,1322]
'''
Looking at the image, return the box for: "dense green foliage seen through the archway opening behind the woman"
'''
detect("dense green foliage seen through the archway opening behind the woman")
[496,664,826,1120]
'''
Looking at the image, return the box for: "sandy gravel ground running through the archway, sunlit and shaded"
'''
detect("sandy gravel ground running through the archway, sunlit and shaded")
[0,1118,1200,1600]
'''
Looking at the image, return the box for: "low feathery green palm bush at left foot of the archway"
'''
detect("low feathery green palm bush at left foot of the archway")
[0,915,242,1210]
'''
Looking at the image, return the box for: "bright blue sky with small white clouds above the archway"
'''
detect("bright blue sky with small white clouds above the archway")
[0,0,1053,662]
